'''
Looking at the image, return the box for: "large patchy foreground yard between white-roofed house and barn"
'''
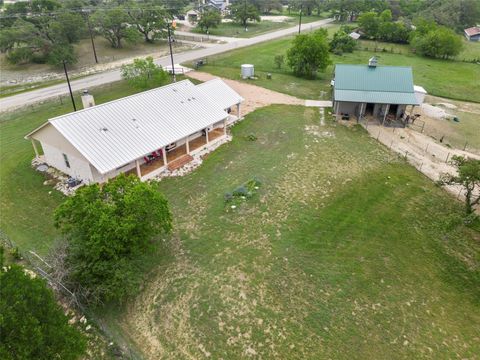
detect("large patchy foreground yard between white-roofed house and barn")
[100,106,480,359]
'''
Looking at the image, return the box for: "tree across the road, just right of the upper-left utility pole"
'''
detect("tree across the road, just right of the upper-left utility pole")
[92,6,139,49]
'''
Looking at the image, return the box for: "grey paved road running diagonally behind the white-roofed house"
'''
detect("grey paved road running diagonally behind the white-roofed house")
[0,19,333,112]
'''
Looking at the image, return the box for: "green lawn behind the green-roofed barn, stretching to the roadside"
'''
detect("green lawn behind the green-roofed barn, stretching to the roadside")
[189,37,480,102]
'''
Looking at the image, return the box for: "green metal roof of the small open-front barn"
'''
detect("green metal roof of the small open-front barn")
[334,64,417,105]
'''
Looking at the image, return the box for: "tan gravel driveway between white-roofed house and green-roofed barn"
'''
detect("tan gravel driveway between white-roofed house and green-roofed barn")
[186,71,305,115]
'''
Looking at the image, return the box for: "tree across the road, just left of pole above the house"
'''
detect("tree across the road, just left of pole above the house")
[127,2,170,43]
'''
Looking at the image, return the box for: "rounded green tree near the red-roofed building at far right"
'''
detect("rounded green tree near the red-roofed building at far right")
[411,26,463,59]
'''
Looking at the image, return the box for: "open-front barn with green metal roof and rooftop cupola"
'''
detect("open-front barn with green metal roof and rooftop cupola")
[333,57,419,124]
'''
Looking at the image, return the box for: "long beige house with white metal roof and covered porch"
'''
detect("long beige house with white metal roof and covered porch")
[25,79,243,183]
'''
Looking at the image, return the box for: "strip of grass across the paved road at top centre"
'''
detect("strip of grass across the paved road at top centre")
[191,14,324,38]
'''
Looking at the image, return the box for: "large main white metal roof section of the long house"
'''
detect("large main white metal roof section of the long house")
[31,80,233,174]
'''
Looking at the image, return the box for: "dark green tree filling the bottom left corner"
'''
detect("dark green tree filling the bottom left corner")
[0,265,86,360]
